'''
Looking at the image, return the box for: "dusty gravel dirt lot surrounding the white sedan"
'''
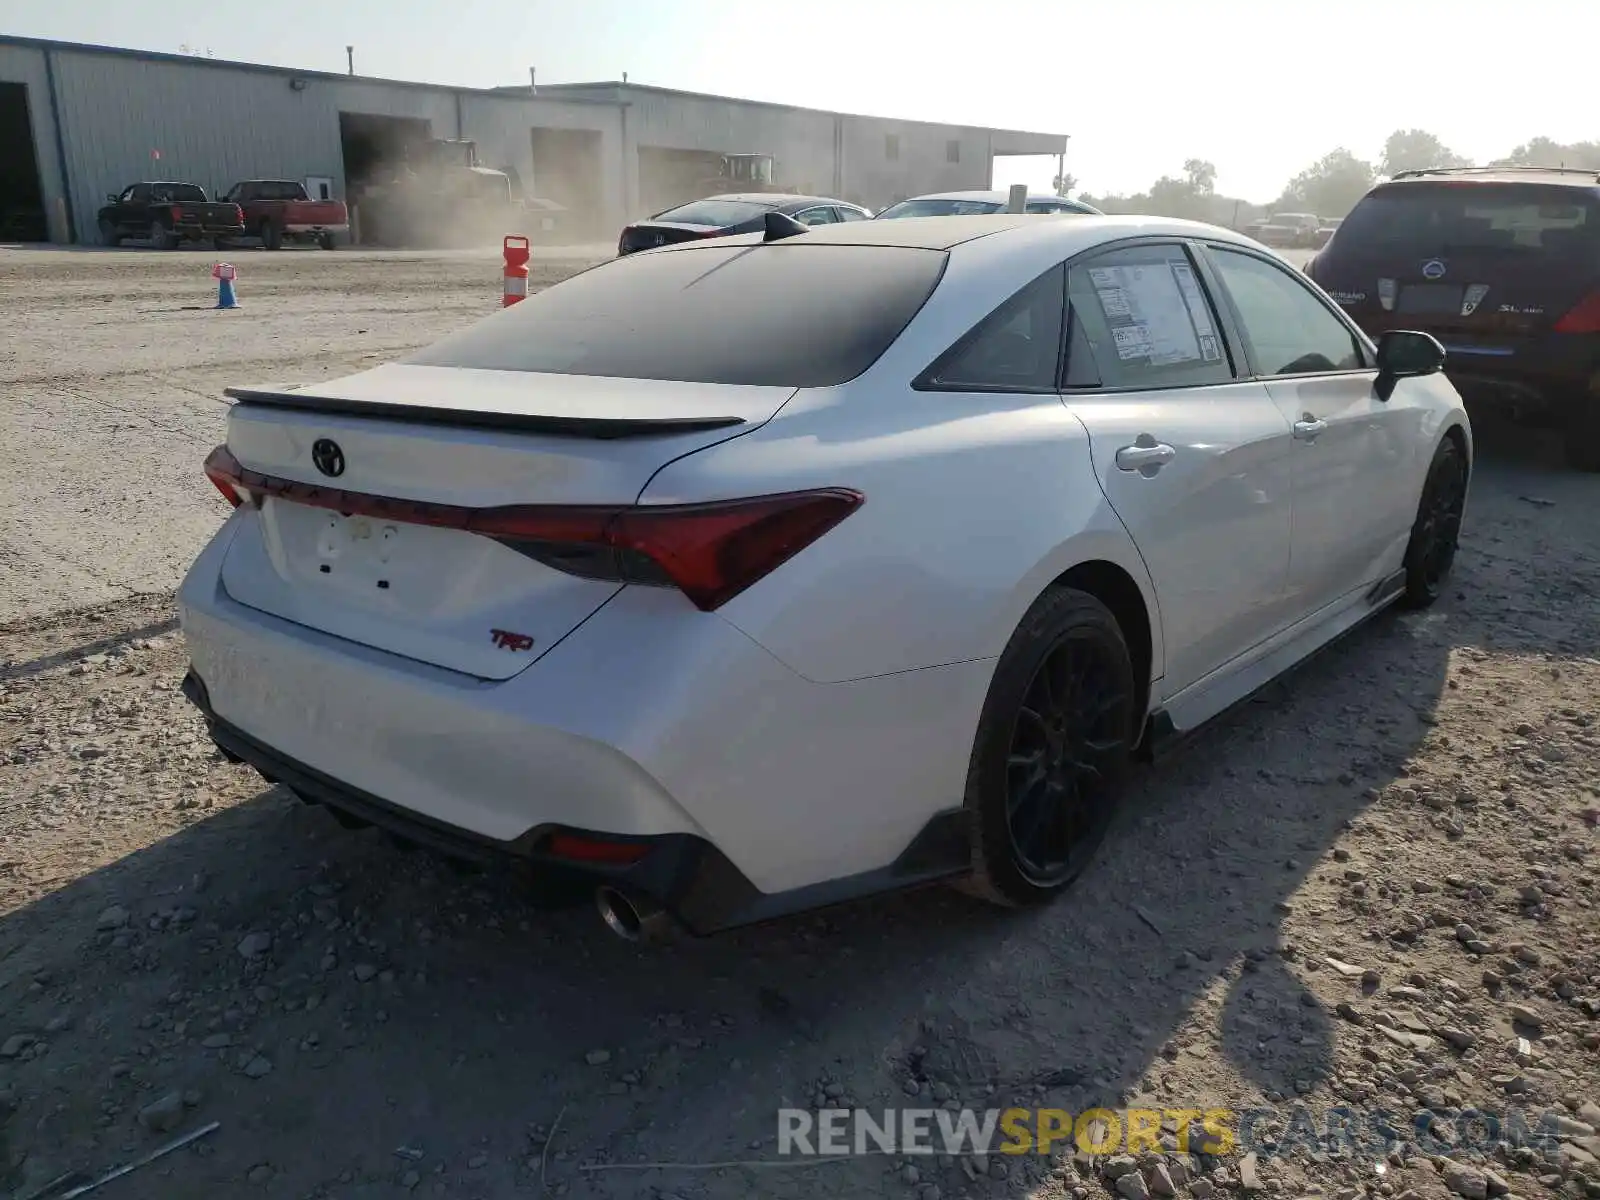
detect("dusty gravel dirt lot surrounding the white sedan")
[0,251,1600,1200]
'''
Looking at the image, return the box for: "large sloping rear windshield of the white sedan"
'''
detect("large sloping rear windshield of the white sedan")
[405,238,947,387]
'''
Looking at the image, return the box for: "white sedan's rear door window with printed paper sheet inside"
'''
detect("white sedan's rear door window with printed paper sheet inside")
[1067,246,1234,389]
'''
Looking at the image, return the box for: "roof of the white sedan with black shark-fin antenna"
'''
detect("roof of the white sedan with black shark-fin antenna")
[645,213,1261,258]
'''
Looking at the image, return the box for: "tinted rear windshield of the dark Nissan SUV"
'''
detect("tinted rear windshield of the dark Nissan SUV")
[1339,184,1600,254]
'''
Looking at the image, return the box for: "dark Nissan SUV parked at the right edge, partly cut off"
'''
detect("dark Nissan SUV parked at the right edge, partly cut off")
[1306,168,1600,470]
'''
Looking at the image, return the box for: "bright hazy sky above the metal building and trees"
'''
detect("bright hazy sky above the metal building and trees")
[0,0,1600,202]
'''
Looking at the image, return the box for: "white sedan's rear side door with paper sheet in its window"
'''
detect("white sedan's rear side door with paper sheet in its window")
[1064,243,1294,696]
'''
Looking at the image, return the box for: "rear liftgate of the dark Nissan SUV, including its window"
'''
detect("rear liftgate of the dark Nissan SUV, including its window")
[1314,179,1600,356]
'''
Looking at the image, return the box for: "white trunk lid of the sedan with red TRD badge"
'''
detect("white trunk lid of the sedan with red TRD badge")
[222,365,794,680]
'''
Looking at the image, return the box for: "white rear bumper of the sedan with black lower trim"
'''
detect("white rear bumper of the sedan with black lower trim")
[179,522,972,933]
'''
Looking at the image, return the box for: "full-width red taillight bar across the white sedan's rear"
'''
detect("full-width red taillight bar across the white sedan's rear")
[206,446,866,613]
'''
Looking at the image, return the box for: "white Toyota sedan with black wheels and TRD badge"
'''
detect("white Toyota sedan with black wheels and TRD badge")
[179,216,1472,936]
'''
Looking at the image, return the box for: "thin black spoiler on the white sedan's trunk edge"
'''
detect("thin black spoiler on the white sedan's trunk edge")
[222,387,744,438]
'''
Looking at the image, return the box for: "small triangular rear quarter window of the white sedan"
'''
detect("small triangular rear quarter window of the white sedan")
[917,267,1066,392]
